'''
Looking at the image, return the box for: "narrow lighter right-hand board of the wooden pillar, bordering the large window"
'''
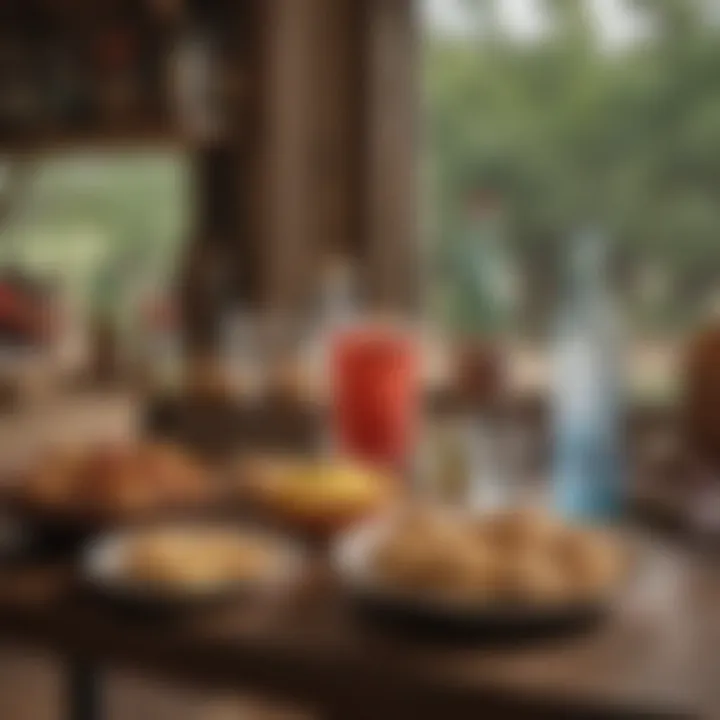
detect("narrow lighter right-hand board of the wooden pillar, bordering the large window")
[361,0,421,310]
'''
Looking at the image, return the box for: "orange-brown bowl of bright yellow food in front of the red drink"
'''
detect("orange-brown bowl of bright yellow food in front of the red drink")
[235,455,399,538]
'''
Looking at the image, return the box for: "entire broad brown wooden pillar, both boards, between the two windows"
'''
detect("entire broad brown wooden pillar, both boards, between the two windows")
[261,0,420,316]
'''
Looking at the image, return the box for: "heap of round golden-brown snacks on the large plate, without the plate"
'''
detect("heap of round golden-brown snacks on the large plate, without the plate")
[373,507,623,605]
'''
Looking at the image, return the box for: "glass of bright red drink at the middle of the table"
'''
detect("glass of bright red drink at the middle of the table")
[331,328,420,470]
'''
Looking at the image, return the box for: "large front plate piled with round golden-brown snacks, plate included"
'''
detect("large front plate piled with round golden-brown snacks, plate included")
[333,507,628,629]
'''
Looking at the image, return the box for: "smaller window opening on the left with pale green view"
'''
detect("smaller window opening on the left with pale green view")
[0,152,191,358]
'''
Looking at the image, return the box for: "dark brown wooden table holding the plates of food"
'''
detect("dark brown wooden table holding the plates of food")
[0,540,720,720]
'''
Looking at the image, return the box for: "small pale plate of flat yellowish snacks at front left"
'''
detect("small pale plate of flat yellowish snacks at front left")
[82,521,301,605]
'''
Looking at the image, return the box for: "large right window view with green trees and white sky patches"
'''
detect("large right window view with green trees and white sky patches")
[423,0,720,400]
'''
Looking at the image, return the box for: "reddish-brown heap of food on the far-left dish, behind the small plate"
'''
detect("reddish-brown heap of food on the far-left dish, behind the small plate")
[18,442,213,524]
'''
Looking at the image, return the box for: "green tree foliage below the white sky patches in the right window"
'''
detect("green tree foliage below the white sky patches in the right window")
[424,0,720,336]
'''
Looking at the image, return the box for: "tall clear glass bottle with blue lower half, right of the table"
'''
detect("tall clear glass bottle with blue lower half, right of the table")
[553,231,624,522]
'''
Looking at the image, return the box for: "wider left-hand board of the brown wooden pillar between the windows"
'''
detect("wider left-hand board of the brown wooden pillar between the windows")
[253,0,363,312]
